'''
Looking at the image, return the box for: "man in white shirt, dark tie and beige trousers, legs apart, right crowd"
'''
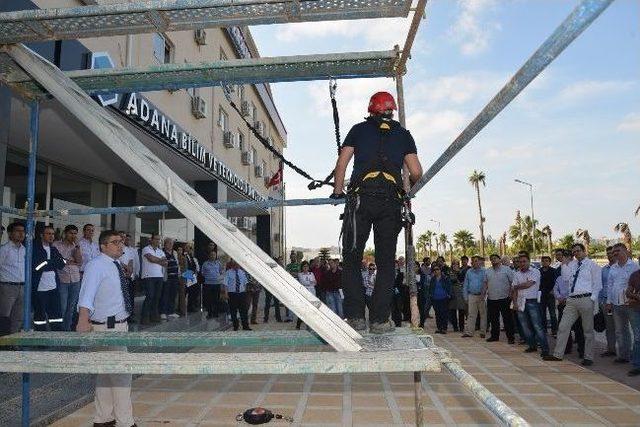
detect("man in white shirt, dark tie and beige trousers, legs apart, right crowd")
[545,243,602,366]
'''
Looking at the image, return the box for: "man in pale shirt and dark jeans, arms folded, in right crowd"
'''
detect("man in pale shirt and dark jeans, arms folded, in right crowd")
[512,253,549,358]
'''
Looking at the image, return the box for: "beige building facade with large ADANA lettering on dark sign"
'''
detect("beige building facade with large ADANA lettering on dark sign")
[0,0,287,256]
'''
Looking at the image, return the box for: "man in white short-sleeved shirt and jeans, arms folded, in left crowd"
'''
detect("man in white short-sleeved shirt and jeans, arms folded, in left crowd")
[140,233,168,325]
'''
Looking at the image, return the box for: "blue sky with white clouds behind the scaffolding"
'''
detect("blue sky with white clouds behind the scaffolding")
[251,0,640,249]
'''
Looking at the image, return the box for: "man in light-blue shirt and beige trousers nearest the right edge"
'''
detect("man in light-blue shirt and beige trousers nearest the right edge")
[606,243,640,363]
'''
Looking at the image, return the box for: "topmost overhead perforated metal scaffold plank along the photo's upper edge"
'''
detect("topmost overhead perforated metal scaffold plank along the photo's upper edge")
[0,0,411,44]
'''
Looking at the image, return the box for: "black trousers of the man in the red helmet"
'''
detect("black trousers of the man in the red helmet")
[342,194,402,323]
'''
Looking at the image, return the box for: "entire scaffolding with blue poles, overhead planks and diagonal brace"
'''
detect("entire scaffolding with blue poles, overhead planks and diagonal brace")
[0,0,612,426]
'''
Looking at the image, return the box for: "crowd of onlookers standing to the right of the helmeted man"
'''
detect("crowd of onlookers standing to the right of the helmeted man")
[396,243,640,376]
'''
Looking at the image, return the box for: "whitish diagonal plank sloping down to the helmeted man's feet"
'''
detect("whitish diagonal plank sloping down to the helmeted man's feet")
[4,44,362,351]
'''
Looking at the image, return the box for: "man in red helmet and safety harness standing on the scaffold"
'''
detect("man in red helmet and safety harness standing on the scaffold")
[331,92,422,333]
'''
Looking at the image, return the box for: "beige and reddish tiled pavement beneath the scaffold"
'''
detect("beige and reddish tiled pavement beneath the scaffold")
[48,324,640,427]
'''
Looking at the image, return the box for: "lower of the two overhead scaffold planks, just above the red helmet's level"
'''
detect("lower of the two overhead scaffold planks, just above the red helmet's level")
[0,50,399,96]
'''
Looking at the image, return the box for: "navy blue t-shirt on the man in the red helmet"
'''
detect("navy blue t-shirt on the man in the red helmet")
[342,119,417,182]
